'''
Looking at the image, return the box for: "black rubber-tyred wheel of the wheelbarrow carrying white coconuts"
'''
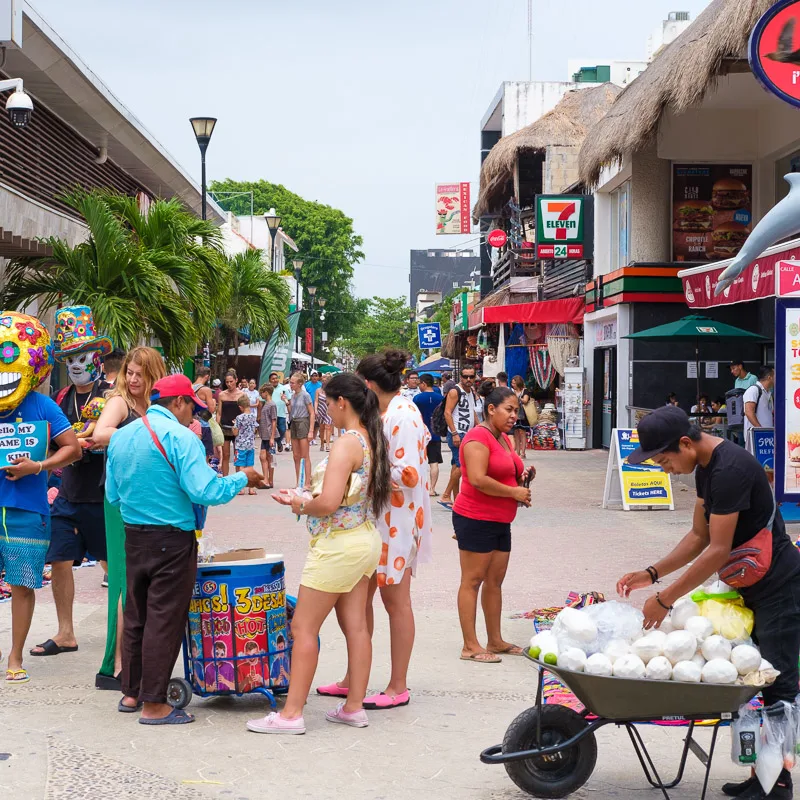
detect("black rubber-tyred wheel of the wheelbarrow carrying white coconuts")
[503,705,597,798]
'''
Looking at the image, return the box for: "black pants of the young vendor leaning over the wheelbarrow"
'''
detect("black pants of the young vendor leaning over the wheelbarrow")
[748,575,800,706]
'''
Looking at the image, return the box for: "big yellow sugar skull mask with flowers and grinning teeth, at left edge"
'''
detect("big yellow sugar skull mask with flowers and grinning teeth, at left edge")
[0,311,53,411]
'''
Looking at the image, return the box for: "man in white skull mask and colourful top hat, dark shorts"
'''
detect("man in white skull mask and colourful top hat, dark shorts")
[30,306,113,656]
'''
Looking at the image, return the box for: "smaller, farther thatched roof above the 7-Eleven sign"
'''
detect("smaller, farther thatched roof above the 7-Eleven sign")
[472,83,622,221]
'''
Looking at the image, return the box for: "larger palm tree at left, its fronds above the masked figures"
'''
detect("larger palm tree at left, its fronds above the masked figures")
[2,189,230,365]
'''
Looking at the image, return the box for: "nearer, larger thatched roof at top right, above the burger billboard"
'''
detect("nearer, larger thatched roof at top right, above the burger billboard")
[580,0,774,186]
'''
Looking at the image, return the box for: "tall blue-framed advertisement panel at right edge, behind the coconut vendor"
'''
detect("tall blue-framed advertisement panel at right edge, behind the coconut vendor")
[775,299,800,503]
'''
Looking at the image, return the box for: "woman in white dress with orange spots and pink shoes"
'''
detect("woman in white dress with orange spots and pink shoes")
[317,350,432,709]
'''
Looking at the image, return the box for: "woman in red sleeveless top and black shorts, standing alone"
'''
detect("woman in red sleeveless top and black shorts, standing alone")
[453,385,536,664]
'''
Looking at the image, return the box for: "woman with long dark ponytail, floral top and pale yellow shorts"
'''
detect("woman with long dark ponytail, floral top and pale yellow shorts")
[247,372,392,734]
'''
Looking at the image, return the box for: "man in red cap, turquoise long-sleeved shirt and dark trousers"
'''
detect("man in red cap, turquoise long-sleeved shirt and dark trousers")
[106,375,263,725]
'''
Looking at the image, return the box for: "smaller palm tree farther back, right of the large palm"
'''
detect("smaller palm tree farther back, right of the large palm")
[218,250,291,374]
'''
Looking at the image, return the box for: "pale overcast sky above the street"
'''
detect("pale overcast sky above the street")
[33,0,708,296]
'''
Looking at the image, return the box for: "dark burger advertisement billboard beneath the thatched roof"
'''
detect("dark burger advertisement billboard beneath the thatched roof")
[672,164,753,261]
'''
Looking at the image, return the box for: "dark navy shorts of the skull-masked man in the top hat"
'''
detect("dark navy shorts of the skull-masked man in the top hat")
[47,497,108,566]
